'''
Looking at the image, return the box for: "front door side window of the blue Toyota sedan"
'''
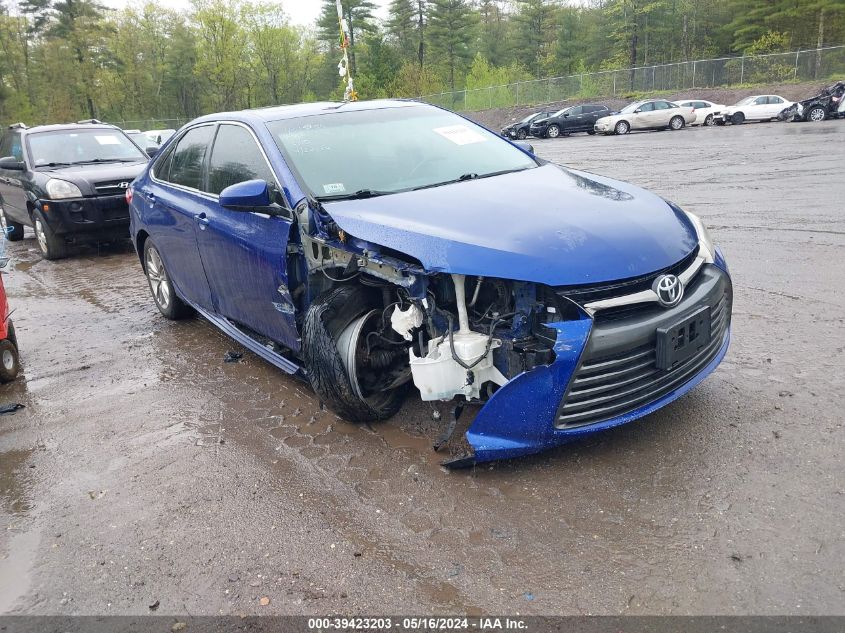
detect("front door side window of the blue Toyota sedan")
[208,125,276,194]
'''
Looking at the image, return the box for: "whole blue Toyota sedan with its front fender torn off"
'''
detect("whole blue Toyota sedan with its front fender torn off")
[127,101,732,466]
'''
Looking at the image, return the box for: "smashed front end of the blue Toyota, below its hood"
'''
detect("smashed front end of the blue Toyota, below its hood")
[292,188,732,467]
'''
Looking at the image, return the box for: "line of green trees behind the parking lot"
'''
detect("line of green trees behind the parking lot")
[0,0,845,124]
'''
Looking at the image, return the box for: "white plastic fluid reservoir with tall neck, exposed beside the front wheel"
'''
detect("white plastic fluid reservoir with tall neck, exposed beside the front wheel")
[409,275,507,400]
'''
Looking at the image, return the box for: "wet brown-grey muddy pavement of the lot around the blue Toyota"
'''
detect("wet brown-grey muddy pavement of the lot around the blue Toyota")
[0,121,845,615]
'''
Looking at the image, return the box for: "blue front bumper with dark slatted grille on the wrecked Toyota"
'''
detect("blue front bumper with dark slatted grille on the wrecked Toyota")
[466,256,733,462]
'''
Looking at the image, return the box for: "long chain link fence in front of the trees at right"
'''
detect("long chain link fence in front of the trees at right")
[419,45,845,111]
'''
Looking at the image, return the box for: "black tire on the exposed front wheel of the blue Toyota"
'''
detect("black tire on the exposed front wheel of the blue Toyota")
[302,284,410,422]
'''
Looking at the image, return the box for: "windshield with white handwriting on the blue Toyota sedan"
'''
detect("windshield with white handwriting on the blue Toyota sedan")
[267,106,537,199]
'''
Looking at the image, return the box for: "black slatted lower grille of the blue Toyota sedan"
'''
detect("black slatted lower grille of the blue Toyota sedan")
[556,278,731,428]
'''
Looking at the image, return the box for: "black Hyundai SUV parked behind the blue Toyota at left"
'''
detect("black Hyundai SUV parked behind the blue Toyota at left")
[0,120,148,259]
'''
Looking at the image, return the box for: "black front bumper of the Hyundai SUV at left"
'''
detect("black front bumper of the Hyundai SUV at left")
[38,194,129,240]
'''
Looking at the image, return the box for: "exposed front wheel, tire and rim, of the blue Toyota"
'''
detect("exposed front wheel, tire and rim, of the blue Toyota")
[302,284,410,422]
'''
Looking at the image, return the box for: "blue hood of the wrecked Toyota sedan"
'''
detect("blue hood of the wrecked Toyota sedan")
[324,164,698,286]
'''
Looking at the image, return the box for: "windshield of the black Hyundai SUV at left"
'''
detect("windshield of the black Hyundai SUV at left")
[28,128,147,167]
